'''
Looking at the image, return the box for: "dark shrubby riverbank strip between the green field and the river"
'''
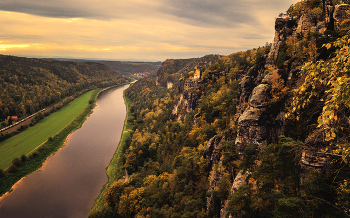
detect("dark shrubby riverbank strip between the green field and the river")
[0,84,131,196]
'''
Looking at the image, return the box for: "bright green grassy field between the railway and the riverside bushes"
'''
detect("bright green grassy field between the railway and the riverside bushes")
[0,91,93,169]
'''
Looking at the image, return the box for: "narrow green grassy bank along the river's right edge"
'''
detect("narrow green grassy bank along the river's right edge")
[89,92,133,217]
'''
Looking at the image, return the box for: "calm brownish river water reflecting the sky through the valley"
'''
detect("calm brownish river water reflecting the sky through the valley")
[0,85,129,218]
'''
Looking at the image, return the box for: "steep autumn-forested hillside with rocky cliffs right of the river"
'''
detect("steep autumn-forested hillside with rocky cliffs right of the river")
[90,0,350,218]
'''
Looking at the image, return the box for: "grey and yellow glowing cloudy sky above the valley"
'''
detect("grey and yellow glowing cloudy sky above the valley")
[0,0,297,61]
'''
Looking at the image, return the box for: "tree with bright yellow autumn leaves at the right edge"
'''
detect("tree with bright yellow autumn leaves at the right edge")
[291,32,350,163]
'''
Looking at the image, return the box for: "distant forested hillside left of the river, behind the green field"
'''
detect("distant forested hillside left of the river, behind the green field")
[0,56,129,126]
